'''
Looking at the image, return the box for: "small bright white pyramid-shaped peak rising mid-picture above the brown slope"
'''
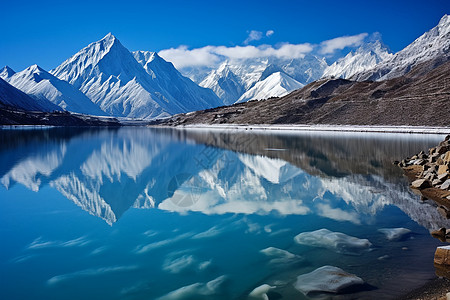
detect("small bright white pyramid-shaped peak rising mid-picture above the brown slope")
[237,72,304,103]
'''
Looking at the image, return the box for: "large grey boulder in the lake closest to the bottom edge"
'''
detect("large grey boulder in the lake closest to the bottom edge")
[294,266,364,295]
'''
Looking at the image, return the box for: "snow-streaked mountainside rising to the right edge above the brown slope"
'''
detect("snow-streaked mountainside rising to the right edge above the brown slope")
[352,15,450,80]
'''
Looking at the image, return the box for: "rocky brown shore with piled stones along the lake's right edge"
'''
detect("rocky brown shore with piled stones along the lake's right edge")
[394,135,450,300]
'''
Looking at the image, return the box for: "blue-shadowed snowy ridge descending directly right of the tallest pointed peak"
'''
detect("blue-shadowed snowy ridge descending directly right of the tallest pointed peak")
[133,51,223,111]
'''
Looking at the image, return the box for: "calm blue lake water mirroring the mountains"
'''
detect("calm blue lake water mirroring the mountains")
[0,128,450,300]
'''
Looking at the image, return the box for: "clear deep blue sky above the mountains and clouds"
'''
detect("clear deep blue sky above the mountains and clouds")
[0,0,450,71]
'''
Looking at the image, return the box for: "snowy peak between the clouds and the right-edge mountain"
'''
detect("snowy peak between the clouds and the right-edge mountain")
[322,41,393,79]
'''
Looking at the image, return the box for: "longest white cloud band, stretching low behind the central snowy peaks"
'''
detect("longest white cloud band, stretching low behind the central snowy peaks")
[158,43,313,68]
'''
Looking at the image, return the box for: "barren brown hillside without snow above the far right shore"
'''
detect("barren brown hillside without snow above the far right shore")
[159,60,450,126]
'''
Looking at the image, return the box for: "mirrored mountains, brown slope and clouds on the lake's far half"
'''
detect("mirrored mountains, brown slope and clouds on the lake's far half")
[0,128,445,229]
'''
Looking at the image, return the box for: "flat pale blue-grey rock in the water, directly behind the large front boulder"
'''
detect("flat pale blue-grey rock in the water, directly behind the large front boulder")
[294,228,372,255]
